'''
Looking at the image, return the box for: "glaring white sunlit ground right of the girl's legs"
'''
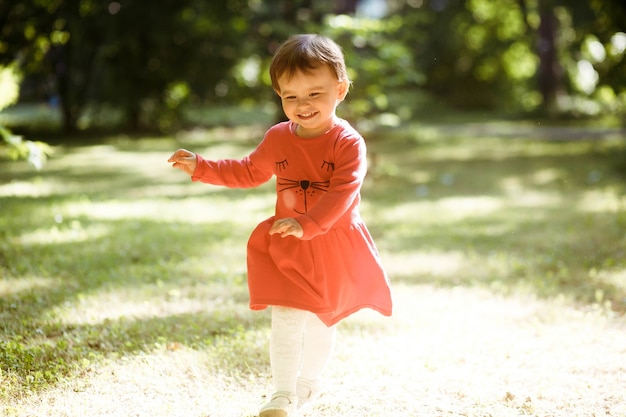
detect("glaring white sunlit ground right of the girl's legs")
[322,285,626,416]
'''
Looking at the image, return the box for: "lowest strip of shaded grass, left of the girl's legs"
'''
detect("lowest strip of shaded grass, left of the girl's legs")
[0,306,269,399]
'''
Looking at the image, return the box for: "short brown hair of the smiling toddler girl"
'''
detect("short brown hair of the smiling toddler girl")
[270,34,349,92]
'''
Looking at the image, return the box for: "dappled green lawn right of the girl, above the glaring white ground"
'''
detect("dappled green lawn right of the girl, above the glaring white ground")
[364,136,626,313]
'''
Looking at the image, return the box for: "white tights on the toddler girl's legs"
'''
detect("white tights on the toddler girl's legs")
[270,306,336,392]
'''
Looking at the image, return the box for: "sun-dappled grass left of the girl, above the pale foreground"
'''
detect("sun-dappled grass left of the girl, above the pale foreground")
[0,136,273,401]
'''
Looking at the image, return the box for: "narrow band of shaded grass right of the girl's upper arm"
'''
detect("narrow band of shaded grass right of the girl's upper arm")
[365,147,623,203]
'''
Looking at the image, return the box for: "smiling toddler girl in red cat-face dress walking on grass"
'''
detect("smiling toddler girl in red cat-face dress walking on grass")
[168,34,392,417]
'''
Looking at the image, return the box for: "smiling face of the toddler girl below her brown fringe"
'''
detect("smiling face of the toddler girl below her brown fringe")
[277,65,348,137]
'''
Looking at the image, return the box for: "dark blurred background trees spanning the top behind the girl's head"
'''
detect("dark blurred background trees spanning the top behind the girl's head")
[0,0,626,136]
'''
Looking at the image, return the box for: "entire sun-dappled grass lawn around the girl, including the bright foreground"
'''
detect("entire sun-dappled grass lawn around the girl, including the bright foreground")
[0,118,626,417]
